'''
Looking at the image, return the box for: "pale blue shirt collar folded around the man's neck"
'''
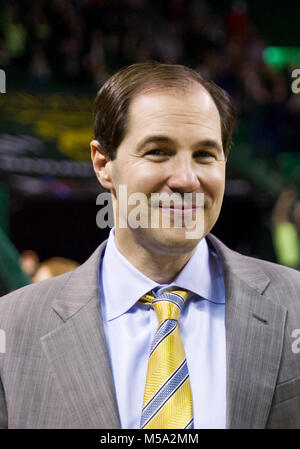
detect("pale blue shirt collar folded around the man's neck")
[100,228,224,321]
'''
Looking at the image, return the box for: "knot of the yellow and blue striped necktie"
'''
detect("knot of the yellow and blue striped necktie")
[140,289,190,324]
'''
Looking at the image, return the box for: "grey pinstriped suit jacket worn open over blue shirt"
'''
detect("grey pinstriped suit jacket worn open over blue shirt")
[0,234,300,429]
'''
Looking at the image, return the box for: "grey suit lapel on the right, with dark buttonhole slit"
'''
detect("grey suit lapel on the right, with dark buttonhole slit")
[209,235,286,428]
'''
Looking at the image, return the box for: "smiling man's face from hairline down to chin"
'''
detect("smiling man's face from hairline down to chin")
[98,86,226,254]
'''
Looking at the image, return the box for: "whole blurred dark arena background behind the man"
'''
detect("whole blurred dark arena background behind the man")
[0,0,300,295]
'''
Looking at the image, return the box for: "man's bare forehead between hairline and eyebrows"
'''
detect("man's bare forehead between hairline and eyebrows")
[127,85,221,139]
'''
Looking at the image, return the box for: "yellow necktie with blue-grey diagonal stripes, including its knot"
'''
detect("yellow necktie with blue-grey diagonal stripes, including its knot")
[140,288,194,429]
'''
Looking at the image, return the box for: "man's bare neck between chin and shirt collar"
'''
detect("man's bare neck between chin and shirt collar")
[115,229,196,284]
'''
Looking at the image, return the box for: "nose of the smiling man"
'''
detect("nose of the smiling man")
[167,157,200,193]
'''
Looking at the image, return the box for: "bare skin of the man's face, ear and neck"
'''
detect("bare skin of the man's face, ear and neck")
[91,77,226,283]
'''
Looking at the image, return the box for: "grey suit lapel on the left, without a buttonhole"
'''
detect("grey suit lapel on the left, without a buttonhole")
[41,242,120,429]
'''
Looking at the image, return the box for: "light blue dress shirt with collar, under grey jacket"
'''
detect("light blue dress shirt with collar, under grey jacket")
[99,228,226,429]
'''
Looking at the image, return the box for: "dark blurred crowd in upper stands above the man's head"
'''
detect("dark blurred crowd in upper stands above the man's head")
[0,0,300,159]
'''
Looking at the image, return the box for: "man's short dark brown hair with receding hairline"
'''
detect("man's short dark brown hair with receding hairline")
[94,61,236,159]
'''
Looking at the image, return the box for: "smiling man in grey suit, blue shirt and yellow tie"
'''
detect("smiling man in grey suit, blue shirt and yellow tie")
[0,63,300,428]
